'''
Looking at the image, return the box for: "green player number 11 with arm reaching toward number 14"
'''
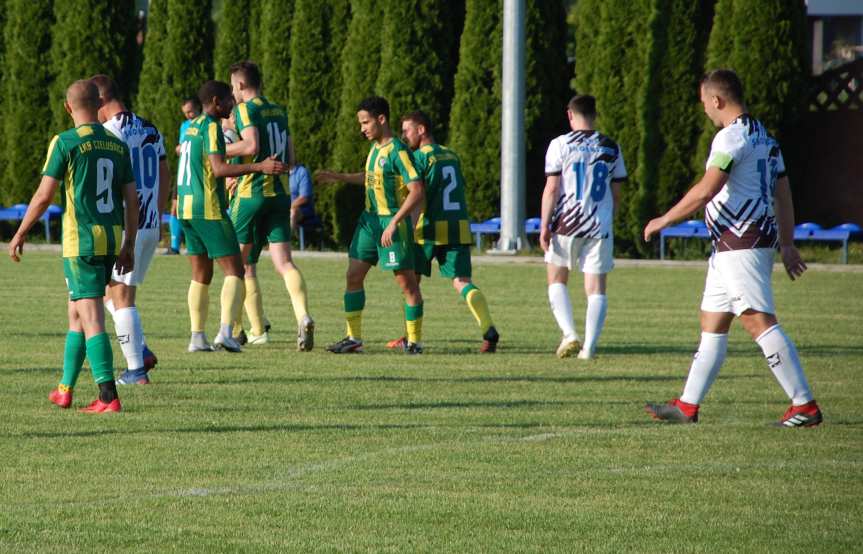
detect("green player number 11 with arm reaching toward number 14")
[177,81,288,352]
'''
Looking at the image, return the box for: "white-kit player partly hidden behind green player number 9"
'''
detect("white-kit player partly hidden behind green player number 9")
[90,75,171,384]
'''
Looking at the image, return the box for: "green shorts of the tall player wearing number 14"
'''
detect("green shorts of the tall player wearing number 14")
[231,194,291,244]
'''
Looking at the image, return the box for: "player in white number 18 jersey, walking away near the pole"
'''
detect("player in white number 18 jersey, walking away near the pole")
[539,95,626,359]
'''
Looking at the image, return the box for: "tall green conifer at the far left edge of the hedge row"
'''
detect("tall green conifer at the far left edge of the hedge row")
[0,0,54,206]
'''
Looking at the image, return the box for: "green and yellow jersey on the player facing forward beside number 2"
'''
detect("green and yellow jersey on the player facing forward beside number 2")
[366,137,422,216]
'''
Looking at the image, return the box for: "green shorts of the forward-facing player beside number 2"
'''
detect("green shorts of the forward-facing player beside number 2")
[348,211,415,271]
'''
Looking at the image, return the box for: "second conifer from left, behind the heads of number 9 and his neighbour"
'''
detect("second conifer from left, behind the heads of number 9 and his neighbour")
[51,0,137,131]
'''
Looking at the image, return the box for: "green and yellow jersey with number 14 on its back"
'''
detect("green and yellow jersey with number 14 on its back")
[234,96,290,198]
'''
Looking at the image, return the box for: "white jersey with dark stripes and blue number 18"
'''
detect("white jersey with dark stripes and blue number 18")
[545,130,627,238]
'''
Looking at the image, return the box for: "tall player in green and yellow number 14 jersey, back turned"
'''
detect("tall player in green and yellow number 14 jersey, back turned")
[227,61,315,352]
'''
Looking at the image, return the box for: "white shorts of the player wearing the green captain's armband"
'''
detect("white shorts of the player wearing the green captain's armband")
[701,248,776,316]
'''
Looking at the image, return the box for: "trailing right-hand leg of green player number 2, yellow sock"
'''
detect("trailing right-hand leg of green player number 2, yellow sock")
[446,244,500,353]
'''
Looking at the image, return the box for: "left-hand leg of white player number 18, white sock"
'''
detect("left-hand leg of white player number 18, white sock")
[545,234,581,358]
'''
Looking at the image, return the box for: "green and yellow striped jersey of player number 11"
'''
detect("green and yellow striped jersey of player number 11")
[177,114,228,220]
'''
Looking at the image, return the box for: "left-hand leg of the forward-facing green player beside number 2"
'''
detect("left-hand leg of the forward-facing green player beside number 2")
[327,212,380,354]
